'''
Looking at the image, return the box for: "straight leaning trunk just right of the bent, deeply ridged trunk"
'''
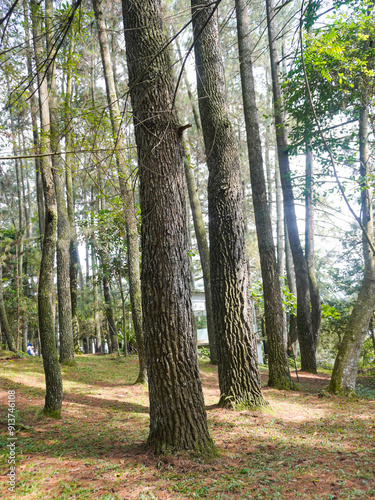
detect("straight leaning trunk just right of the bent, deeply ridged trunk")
[236,0,292,389]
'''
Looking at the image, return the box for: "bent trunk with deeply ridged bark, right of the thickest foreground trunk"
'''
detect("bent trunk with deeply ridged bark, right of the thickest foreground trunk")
[191,0,265,407]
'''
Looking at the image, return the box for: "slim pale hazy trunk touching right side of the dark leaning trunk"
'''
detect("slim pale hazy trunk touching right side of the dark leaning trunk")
[305,142,322,345]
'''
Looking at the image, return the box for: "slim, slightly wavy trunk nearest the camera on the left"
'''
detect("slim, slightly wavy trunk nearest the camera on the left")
[30,0,63,418]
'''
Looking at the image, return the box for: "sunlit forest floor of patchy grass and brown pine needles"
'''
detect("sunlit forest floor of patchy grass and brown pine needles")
[0,355,375,500]
